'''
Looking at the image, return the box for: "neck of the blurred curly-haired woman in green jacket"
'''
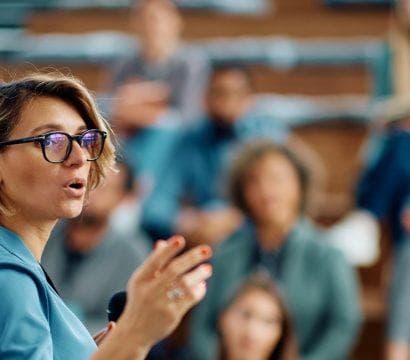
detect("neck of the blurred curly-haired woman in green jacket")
[256,215,296,251]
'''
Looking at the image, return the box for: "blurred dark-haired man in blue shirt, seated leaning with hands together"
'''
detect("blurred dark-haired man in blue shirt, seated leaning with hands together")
[142,64,290,244]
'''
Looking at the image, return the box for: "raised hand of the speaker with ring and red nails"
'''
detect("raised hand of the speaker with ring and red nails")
[118,236,212,349]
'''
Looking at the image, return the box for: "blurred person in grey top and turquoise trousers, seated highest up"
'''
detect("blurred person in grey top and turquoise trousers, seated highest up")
[111,0,209,198]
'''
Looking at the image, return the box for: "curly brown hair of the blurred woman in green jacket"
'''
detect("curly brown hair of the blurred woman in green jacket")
[228,139,310,216]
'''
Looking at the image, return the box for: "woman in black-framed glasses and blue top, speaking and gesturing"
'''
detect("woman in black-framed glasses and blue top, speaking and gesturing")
[0,75,211,359]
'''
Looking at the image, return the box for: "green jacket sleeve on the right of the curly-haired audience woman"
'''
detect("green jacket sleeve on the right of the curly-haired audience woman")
[303,249,362,360]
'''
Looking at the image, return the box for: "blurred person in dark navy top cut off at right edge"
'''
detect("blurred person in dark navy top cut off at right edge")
[357,97,410,250]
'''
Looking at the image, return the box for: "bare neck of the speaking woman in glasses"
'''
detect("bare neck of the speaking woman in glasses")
[0,215,57,262]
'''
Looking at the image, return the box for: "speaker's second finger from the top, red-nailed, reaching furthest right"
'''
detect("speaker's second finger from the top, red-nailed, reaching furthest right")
[162,245,212,282]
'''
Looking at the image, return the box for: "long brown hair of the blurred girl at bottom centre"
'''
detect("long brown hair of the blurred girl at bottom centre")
[218,271,298,360]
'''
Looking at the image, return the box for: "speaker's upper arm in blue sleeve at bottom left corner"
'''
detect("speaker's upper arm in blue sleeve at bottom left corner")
[0,268,53,360]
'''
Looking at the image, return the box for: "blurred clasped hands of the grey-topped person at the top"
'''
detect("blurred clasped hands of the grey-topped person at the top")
[112,81,170,132]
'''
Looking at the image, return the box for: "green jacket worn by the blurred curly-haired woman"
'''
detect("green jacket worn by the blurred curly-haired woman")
[189,220,361,360]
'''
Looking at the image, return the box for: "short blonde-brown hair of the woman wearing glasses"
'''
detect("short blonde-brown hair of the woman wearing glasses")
[0,73,115,213]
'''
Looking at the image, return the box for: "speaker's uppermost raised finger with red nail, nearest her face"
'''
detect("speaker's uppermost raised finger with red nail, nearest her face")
[140,235,185,277]
